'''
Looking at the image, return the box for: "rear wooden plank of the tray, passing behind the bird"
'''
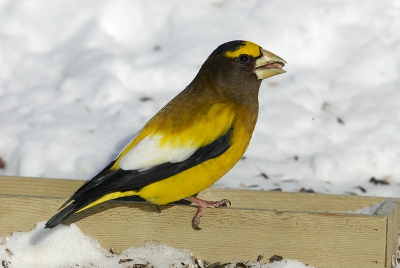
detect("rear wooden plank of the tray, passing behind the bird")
[0,176,386,212]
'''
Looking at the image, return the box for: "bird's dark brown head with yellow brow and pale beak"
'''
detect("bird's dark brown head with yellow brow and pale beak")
[189,41,286,107]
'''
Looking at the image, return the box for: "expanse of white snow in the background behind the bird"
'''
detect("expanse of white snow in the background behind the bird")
[0,0,400,267]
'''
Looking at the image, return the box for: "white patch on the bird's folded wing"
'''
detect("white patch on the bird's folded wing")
[119,135,198,170]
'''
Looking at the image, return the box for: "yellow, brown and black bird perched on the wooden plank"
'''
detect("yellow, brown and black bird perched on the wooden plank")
[45,40,286,230]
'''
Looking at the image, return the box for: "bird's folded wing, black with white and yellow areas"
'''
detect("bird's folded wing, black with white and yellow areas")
[70,101,235,202]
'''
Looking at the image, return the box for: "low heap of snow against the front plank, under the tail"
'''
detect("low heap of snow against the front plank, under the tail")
[0,222,310,268]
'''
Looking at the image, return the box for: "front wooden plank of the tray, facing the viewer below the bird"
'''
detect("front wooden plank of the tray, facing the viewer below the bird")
[0,196,390,267]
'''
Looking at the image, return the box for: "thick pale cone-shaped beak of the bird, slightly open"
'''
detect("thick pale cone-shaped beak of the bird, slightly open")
[253,48,286,79]
